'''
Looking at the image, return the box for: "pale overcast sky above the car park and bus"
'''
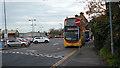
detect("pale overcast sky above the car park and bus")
[0,0,88,32]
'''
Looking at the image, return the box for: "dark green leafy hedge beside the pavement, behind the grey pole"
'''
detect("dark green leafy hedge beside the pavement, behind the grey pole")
[91,3,120,68]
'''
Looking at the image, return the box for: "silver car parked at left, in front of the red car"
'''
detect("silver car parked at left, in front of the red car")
[7,39,28,47]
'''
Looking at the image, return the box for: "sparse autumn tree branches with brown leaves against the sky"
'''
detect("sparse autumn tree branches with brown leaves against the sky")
[86,0,106,18]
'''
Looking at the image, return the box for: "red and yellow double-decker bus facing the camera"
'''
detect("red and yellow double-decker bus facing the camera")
[64,17,85,47]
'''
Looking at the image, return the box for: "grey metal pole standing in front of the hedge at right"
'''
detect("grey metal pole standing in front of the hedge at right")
[109,2,114,54]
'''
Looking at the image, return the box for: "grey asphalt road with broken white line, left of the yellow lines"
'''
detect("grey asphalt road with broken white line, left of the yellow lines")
[2,38,78,66]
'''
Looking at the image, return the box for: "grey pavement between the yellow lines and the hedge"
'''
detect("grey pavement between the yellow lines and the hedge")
[60,40,105,66]
